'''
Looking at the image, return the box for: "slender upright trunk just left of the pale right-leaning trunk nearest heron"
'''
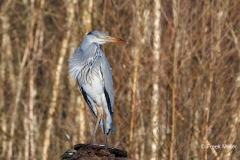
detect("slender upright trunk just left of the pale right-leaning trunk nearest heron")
[25,0,45,160]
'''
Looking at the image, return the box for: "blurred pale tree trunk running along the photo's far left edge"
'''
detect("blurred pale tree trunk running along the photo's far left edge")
[0,1,15,157]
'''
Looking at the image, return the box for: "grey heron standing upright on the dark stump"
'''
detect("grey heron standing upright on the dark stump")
[69,30,128,147]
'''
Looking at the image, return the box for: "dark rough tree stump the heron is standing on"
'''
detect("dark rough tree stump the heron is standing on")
[61,144,130,160]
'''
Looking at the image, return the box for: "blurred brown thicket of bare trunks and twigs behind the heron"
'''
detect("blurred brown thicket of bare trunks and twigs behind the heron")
[0,0,240,160]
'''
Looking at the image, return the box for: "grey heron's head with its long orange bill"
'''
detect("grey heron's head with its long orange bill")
[84,30,128,45]
